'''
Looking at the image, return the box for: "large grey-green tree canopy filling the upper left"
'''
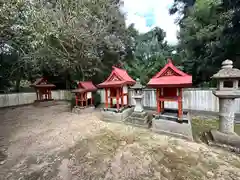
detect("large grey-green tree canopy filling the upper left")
[0,0,128,89]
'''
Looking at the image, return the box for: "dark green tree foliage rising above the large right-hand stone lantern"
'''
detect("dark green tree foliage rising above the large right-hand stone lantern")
[172,0,240,86]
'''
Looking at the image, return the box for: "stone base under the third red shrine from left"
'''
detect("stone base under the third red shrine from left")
[101,107,134,122]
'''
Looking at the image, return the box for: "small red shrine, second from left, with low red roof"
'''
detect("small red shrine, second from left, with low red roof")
[72,81,97,107]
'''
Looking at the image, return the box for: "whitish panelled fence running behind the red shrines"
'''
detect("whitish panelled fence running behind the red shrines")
[0,89,240,113]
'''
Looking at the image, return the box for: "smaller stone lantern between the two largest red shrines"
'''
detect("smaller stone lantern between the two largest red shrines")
[131,79,144,112]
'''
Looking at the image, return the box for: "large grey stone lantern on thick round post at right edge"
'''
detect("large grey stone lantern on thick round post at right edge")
[212,60,240,134]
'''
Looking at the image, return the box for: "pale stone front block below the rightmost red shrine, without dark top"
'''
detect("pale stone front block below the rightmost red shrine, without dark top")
[152,118,193,141]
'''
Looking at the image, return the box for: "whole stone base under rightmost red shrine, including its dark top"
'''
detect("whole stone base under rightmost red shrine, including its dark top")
[152,110,193,141]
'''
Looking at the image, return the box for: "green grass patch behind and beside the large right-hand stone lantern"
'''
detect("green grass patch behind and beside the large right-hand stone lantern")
[192,118,240,140]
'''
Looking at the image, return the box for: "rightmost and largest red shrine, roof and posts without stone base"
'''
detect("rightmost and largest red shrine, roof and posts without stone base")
[147,59,192,119]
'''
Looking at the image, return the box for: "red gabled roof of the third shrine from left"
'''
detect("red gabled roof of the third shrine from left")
[98,66,136,88]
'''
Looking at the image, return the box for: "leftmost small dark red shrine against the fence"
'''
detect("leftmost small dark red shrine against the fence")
[30,78,55,101]
